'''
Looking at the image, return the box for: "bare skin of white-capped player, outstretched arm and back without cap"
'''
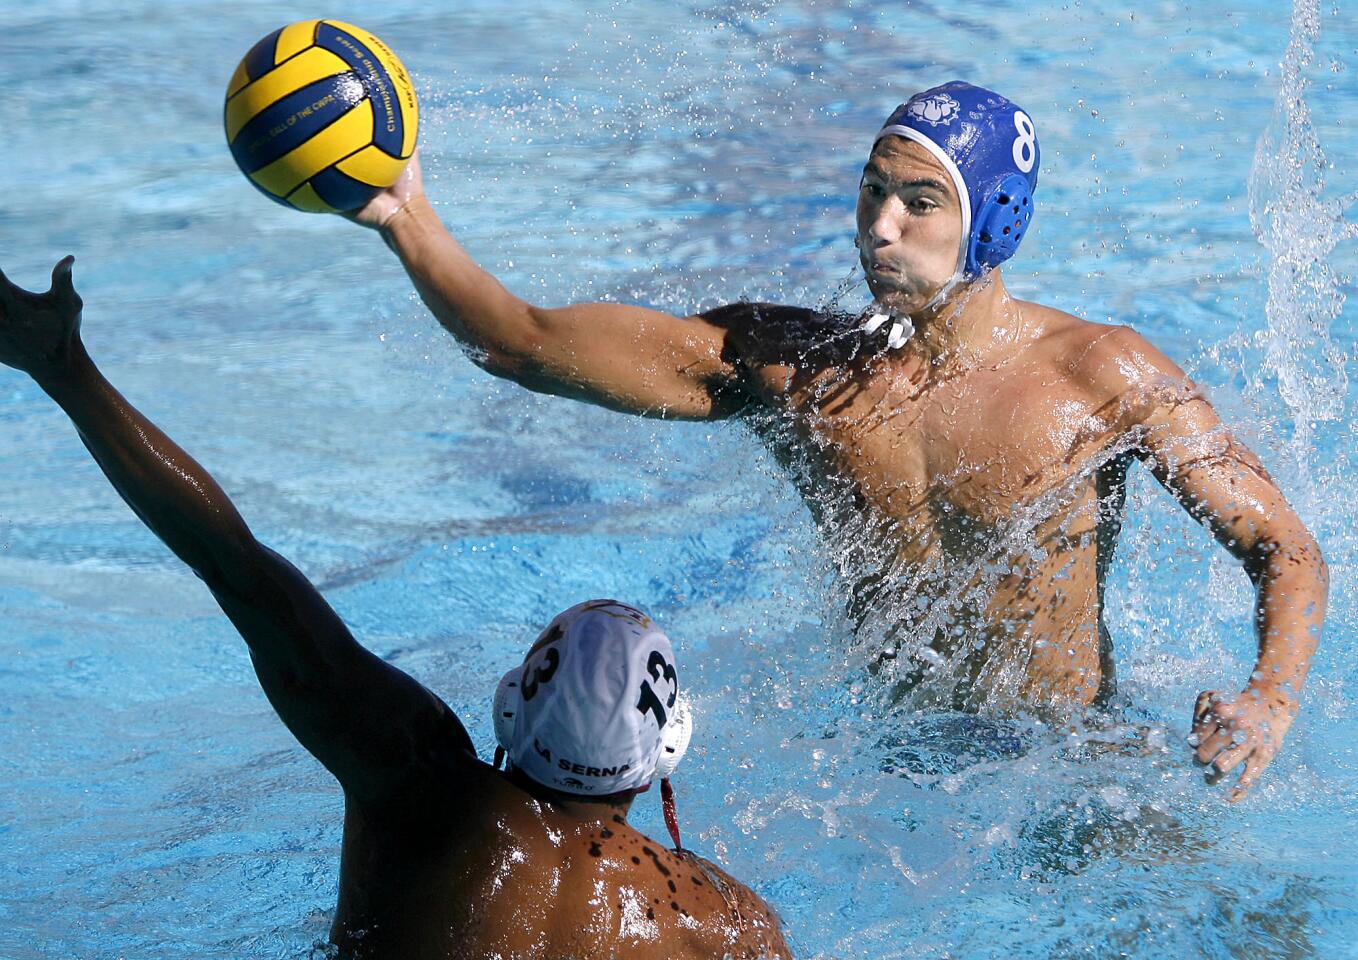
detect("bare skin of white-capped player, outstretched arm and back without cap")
[0,258,789,960]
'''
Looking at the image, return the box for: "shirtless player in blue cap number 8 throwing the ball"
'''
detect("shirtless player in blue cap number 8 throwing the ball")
[350,81,1327,797]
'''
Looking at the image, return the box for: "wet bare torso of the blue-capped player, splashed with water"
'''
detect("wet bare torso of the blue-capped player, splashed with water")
[732,303,1131,709]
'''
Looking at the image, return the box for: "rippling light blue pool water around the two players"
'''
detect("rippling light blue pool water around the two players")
[0,0,1358,960]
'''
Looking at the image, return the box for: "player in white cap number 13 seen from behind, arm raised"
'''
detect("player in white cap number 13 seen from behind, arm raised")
[0,258,790,960]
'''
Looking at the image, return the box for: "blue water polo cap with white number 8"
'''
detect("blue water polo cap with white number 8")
[877,80,1039,280]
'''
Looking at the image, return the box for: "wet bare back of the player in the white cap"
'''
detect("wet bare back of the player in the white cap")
[331,759,790,960]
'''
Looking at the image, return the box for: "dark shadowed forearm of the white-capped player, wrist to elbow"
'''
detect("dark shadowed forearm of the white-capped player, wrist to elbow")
[35,345,254,584]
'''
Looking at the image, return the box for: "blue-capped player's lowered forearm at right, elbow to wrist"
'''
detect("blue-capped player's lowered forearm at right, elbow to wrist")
[1249,538,1329,699]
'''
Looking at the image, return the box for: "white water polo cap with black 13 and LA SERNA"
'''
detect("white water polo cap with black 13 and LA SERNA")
[494,600,691,796]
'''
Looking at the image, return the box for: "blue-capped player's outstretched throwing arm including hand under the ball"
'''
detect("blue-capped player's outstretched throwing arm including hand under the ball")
[352,155,746,420]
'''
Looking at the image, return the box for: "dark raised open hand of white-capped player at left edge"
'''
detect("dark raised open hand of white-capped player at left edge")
[0,257,81,376]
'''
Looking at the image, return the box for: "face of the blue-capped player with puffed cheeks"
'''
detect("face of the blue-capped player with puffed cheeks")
[858,137,961,312]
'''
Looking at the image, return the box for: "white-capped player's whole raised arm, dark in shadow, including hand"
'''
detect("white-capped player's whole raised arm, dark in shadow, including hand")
[0,257,473,800]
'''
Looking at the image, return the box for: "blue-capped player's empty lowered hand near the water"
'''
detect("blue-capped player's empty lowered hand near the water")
[1188,687,1297,802]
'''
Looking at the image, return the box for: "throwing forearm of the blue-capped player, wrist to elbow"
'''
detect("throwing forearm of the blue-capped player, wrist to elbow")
[383,196,535,373]
